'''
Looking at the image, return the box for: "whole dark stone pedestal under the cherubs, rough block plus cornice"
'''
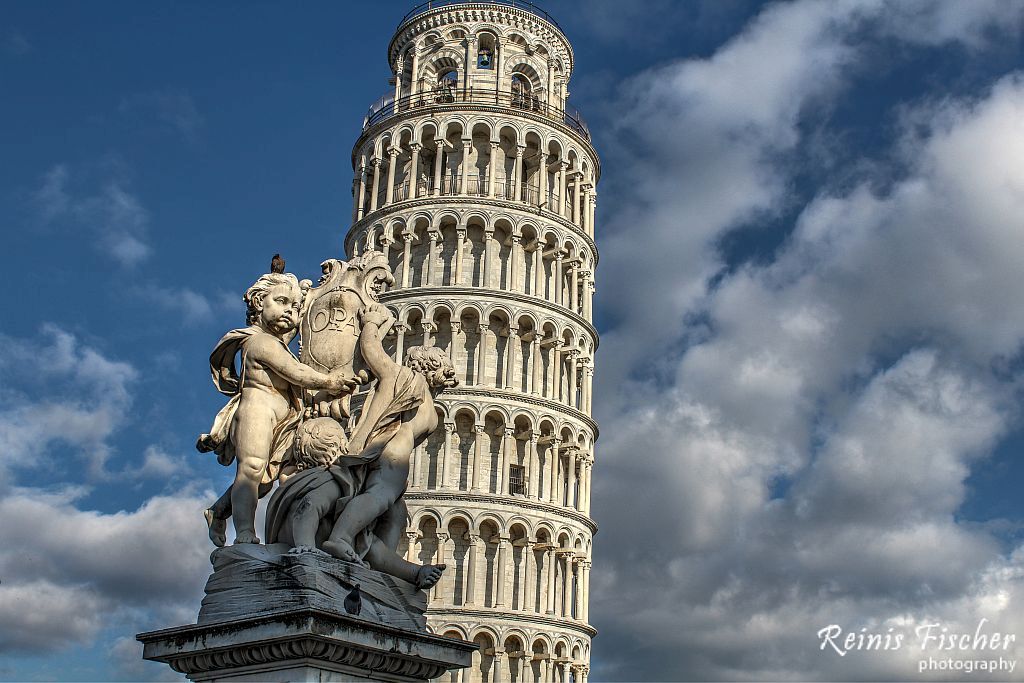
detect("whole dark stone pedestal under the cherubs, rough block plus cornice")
[136,545,477,683]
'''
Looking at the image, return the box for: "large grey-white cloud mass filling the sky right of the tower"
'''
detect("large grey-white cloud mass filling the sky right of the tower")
[592,2,1024,680]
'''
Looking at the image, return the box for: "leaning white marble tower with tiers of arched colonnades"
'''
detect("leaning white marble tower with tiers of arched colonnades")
[345,1,600,683]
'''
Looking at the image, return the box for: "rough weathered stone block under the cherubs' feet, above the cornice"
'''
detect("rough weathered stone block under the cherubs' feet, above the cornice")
[199,544,427,631]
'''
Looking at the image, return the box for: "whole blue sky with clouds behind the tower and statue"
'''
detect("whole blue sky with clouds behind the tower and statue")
[0,0,1024,680]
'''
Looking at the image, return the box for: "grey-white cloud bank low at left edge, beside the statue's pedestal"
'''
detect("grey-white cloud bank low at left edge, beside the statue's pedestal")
[0,488,213,652]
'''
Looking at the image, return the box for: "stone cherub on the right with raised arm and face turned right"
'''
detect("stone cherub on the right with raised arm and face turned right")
[322,303,459,562]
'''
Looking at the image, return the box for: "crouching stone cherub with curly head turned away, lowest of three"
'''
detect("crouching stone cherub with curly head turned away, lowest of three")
[266,417,444,589]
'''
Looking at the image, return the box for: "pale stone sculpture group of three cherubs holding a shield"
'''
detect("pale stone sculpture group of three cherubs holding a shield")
[197,252,458,598]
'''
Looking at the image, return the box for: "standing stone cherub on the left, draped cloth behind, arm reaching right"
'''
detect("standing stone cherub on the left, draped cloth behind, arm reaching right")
[196,264,357,546]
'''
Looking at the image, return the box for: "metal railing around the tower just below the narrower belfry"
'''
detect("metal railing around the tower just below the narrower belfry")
[362,87,590,141]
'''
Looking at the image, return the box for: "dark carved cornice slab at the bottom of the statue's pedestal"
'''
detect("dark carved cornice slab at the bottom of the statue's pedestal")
[137,607,477,683]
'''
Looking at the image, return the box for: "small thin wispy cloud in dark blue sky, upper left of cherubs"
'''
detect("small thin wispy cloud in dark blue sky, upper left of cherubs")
[34,164,152,266]
